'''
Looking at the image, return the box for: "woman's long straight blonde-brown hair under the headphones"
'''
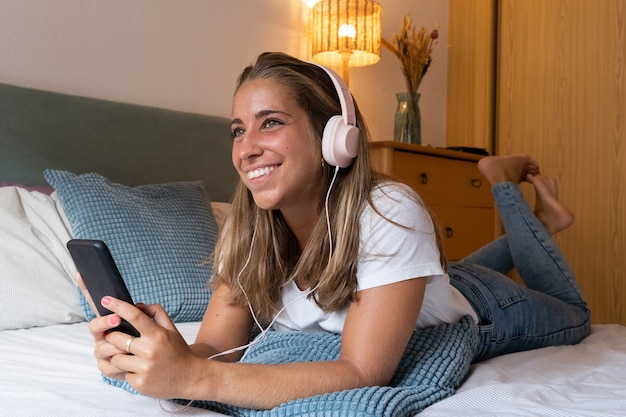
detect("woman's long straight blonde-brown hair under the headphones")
[214,53,443,322]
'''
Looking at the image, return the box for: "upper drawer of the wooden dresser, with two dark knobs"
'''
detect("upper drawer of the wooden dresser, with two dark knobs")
[393,151,493,207]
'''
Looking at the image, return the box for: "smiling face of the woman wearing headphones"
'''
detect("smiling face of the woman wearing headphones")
[231,79,321,224]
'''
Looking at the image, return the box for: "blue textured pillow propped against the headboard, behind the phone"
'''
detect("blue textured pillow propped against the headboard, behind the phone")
[44,170,217,322]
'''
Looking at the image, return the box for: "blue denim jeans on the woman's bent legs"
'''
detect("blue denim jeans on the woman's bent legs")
[448,182,591,362]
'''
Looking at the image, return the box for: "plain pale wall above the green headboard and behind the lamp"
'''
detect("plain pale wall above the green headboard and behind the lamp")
[0,0,448,146]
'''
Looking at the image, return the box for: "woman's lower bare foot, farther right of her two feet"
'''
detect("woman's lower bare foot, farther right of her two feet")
[526,174,574,235]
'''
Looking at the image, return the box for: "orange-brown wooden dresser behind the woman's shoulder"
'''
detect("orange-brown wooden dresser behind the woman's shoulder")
[371,142,496,260]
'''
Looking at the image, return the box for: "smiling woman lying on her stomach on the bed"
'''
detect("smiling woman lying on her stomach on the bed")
[84,53,589,409]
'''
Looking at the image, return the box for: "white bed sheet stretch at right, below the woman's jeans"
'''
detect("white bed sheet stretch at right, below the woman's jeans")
[420,325,626,417]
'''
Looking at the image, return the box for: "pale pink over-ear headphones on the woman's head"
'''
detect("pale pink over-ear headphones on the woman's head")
[311,62,359,168]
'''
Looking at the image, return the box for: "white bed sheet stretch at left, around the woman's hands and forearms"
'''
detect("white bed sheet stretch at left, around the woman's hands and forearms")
[0,322,223,417]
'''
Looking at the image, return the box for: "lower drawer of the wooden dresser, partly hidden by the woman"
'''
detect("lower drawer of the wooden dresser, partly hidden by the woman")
[430,206,495,260]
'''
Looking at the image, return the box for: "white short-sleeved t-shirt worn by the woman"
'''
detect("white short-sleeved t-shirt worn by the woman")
[274,183,478,334]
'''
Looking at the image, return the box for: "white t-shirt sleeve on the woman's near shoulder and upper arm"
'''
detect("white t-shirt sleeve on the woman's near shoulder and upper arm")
[357,184,444,290]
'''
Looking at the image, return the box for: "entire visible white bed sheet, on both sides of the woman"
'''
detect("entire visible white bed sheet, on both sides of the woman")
[0,323,626,417]
